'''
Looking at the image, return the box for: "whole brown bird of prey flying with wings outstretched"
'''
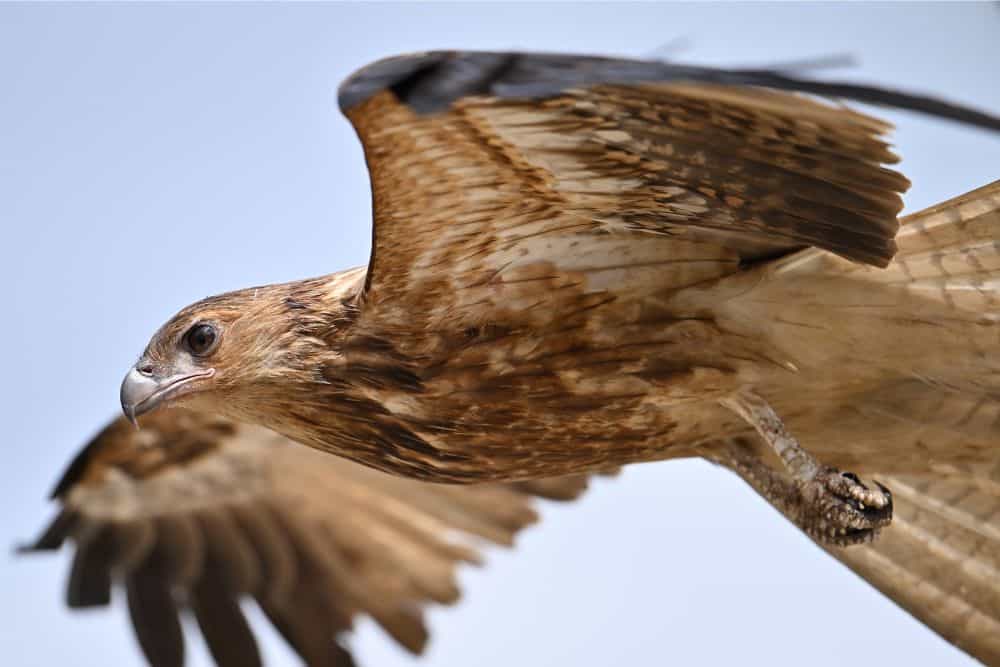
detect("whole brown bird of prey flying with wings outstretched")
[19,51,1000,664]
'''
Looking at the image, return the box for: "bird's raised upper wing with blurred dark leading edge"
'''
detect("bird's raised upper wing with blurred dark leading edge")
[340,52,1000,332]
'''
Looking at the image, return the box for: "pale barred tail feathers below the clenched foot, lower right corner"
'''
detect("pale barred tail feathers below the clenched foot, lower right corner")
[827,472,1000,665]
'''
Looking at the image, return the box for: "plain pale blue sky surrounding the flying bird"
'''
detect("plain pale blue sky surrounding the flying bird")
[0,3,1000,667]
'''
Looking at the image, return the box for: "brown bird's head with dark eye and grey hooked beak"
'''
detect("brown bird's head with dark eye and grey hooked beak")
[121,272,360,423]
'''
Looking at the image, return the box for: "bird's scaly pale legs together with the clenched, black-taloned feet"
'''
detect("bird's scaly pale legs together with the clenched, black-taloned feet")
[720,390,892,545]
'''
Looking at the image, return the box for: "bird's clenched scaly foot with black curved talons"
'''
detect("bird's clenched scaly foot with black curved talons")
[796,468,892,546]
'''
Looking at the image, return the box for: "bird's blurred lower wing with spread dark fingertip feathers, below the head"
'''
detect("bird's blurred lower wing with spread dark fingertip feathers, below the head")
[28,410,586,667]
